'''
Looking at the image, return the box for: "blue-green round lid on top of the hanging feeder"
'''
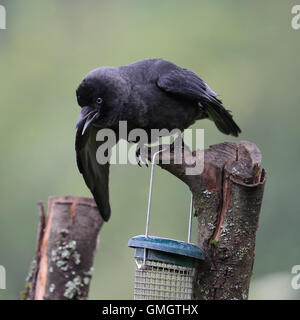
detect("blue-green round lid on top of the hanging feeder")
[128,235,204,267]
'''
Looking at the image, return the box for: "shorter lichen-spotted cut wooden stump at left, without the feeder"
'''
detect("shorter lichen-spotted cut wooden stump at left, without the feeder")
[23,196,103,300]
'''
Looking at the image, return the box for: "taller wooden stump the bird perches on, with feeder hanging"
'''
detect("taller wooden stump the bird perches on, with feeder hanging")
[151,141,266,300]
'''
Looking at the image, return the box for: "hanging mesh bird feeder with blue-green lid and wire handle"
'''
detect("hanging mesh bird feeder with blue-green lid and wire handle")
[128,151,204,300]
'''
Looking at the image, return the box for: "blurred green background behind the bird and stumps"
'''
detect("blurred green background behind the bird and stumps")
[0,0,300,299]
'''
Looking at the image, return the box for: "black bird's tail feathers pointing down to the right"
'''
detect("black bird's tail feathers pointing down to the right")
[201,97,241,137]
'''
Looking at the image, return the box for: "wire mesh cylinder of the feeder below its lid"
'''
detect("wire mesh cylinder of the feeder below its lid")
[134,258,195,300]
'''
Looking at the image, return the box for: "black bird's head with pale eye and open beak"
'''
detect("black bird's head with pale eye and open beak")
[76,67,122,134]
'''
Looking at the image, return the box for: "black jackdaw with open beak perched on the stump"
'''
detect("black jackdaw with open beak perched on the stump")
[75,59,241,221]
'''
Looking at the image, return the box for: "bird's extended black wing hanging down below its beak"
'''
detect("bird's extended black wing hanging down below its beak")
[75,126,111,221]
